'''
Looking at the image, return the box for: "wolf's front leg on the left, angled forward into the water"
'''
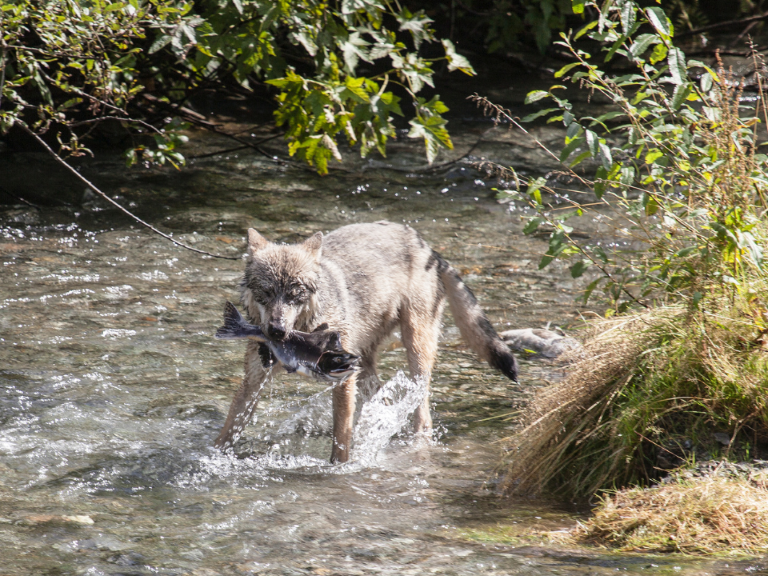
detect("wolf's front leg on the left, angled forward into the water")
[213,341,272,451]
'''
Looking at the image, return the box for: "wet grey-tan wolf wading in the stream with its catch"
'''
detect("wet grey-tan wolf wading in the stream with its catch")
[214,221,517,463]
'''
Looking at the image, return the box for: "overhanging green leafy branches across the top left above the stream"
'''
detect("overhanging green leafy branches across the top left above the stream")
[0,0,474,173]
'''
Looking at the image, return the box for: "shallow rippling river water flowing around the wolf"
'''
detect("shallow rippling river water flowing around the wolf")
[0,99,766,576]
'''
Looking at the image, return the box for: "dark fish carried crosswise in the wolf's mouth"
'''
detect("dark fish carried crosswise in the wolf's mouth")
[215,302,360,382]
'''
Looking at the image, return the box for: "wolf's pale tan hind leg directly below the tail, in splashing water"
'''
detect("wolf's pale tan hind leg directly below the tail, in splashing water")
[401,304,443,432]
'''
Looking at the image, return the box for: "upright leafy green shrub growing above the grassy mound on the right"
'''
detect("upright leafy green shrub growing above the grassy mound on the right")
[492,0,768,311]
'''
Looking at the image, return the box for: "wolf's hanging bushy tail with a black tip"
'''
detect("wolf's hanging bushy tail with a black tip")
[433,252,517,382]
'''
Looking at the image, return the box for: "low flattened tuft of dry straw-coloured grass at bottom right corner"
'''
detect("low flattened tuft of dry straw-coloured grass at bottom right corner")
[576,477,768,554]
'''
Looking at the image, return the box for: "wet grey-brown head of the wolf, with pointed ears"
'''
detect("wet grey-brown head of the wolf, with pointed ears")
[241,228,323,340]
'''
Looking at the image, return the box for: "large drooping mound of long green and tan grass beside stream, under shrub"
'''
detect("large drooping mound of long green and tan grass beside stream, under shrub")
[504,272,768,496]
